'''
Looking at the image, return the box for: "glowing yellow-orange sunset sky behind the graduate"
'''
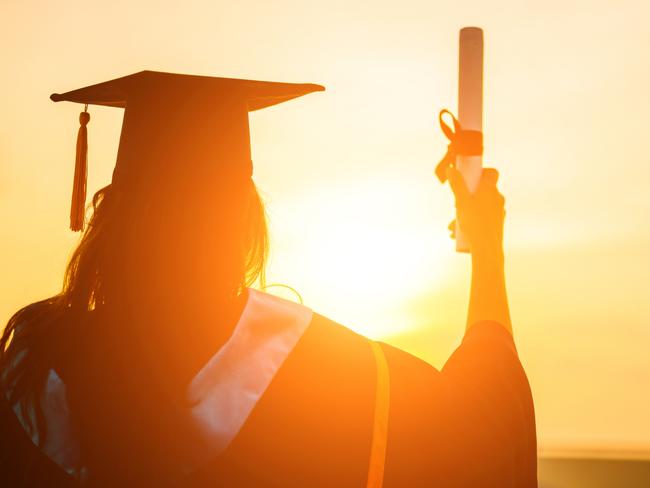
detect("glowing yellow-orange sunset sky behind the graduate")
[0,0,650,452]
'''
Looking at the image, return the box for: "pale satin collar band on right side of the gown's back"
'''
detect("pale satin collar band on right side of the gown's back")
[187,290,313,470]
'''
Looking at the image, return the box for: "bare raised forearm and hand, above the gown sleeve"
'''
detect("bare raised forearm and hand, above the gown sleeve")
[448,168,512,334]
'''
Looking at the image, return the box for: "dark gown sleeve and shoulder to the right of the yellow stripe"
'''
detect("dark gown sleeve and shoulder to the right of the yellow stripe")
[382,322,537,488]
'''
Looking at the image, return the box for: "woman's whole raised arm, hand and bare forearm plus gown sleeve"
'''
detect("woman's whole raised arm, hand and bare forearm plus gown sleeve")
[442,168,537,488]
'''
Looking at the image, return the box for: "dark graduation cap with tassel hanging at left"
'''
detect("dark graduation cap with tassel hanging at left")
[50,71,325,231]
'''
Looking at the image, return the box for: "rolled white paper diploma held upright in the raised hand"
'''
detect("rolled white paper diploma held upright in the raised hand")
[456,27,483,252]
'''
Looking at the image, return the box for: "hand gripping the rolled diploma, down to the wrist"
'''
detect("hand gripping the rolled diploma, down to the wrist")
[447,167,505,256]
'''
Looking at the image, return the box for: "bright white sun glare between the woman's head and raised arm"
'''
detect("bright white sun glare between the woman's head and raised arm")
[260,176,450,337]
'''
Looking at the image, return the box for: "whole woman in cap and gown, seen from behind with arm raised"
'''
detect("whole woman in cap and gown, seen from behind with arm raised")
[0,71,537,487]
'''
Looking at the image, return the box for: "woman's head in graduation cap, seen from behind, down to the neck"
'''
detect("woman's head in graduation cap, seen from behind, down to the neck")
[52,71,323,316]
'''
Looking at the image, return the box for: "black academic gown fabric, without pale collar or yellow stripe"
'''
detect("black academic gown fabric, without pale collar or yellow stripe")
[0,314,537,488]
